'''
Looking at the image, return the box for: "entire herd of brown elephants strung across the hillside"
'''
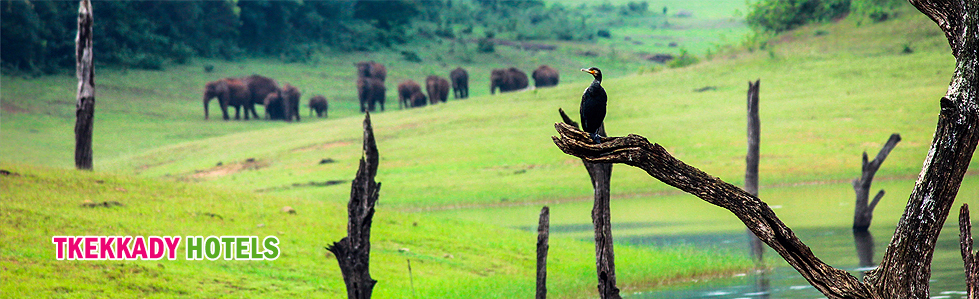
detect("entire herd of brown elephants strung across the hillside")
[204,61,558,121]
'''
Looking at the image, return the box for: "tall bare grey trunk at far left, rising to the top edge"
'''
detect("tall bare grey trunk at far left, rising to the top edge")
[75,0,95,170]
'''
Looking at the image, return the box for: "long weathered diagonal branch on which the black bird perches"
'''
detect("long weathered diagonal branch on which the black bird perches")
[552,123,872,298]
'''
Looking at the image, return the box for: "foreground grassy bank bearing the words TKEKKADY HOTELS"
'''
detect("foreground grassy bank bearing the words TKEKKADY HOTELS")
[0,164,749,298]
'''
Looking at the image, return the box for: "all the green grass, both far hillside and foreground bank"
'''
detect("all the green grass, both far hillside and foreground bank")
[0,2,968,298]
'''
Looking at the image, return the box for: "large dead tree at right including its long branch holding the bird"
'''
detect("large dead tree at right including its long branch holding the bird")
[553,0,979,298]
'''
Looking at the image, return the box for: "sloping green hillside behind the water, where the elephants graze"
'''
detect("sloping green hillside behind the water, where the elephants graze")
[0,4,953,208]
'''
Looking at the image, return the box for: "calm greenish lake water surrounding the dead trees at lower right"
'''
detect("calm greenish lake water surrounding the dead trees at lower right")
[425,176,979,299]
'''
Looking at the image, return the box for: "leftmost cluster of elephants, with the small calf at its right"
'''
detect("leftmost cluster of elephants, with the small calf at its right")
[204,75,329,121]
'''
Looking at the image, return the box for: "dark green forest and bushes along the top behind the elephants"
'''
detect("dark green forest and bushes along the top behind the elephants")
[0,0,899,74]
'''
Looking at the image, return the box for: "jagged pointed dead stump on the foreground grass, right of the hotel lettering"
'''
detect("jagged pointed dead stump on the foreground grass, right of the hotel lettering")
[327,113,381,299]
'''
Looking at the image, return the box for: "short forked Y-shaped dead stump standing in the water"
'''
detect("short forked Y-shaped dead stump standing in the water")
[853,133,901,232]
